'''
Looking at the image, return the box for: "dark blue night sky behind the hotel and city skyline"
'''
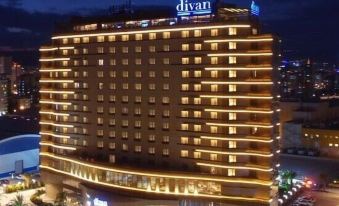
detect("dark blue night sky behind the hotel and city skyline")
[0,0,339,65]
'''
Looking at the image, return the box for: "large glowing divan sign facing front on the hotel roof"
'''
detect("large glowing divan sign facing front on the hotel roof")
[176,0,212,16]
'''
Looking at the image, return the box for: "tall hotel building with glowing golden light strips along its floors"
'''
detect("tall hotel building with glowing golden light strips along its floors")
[40,2,279,205]
